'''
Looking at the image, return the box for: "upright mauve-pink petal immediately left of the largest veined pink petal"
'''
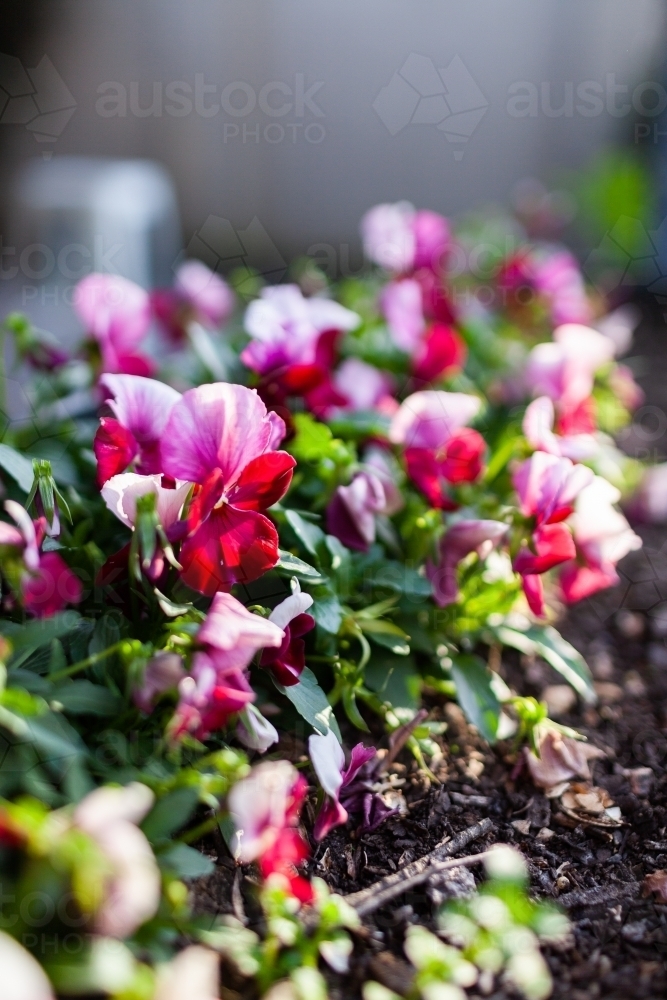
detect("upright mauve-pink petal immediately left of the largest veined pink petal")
[100,373,181,444]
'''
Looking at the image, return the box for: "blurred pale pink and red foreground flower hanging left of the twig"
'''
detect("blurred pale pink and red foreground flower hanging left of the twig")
[227,760,313,902]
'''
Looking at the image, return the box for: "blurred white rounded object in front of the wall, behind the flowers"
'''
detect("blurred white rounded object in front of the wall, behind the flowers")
[10,156,182,288]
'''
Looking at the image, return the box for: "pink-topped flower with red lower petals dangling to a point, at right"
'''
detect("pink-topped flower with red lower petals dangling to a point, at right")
[513,451,593,616]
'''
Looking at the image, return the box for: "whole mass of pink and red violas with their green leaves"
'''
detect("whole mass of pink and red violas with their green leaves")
[0,204,641,1000]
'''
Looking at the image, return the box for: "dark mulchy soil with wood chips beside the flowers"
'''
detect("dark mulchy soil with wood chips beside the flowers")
[197,298,667,1000]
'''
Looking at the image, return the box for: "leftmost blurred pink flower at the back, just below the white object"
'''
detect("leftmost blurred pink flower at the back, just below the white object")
[74,274,154,375]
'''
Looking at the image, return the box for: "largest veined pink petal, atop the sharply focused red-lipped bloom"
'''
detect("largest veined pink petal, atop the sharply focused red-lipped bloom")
[161,382,278,486]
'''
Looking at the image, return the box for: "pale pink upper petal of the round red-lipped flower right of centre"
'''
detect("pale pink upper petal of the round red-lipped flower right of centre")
[389,389,482,449]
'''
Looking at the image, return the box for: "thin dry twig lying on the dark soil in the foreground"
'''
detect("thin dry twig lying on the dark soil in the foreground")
[344,819,493,917]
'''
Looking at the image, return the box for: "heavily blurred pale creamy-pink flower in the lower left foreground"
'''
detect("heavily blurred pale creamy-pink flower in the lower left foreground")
[73,782,161,938]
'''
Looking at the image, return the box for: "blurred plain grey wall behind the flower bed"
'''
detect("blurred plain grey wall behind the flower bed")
[0,0,664,269]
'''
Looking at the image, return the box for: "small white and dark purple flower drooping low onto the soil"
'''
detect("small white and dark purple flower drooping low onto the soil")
[308,729,394,841]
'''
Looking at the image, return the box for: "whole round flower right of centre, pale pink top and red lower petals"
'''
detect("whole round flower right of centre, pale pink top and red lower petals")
[389,390,486,510]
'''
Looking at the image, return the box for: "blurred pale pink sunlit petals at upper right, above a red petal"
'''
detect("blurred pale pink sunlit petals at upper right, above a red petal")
[524,323,614,415]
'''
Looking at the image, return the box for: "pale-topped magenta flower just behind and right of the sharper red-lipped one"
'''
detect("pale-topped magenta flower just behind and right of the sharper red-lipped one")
[560,476,642,604]
